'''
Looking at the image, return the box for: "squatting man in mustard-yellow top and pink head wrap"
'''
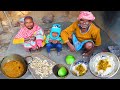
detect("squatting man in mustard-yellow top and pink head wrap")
[61,11,101,56]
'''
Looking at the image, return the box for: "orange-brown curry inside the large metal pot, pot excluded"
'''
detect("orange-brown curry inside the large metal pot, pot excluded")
[2,60,25,78]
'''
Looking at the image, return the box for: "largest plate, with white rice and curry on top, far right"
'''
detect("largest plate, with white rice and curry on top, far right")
[89,52,120,78]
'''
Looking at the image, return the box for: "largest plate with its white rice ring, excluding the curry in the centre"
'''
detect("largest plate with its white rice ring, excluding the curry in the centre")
[89,52,120,78]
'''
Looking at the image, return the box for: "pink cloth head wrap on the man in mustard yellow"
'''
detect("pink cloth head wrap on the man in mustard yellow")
[77,11,95,21]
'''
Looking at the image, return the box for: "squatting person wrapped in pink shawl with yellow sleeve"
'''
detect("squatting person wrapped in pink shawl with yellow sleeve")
[13,16,44,51]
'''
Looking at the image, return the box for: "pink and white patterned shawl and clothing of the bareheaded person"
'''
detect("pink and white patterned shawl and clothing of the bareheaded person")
[15,24,44,50]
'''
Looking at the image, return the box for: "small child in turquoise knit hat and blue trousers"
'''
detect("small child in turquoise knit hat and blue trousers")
[46,24,62,57]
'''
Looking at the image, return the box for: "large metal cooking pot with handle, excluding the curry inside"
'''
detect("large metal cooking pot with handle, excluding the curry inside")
[0,54,30,78]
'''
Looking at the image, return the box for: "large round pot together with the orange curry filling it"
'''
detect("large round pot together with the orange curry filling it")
[0,54,28,78]
